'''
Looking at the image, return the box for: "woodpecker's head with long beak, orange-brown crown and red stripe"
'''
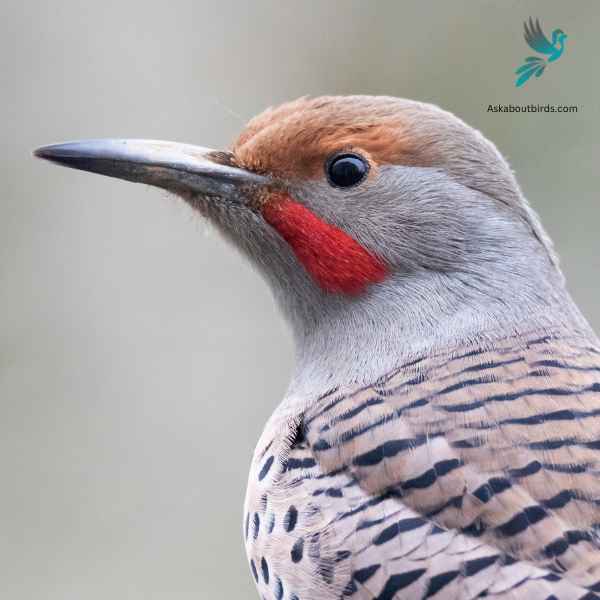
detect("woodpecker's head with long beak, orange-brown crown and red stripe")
[36,96,568,384]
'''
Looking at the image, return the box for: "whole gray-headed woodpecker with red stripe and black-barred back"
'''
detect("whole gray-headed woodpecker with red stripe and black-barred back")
[35,95,600,600]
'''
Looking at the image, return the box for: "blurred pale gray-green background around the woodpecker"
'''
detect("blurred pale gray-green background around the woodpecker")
[0,0,600,600]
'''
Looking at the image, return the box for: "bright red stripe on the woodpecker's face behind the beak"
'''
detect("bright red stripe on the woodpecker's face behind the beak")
[263,195,387,295]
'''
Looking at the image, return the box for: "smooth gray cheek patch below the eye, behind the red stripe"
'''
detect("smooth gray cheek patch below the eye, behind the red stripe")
[290,166,474,274]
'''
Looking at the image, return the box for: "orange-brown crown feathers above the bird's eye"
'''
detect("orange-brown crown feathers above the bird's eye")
[232,96,434,179]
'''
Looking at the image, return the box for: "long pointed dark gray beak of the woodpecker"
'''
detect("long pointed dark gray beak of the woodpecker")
[34,139,269,197]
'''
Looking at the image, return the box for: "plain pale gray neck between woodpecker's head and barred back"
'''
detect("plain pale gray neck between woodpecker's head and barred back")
[283,237,594,404]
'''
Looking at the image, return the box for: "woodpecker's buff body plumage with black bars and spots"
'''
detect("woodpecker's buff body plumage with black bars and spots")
[246,332,600,599]
